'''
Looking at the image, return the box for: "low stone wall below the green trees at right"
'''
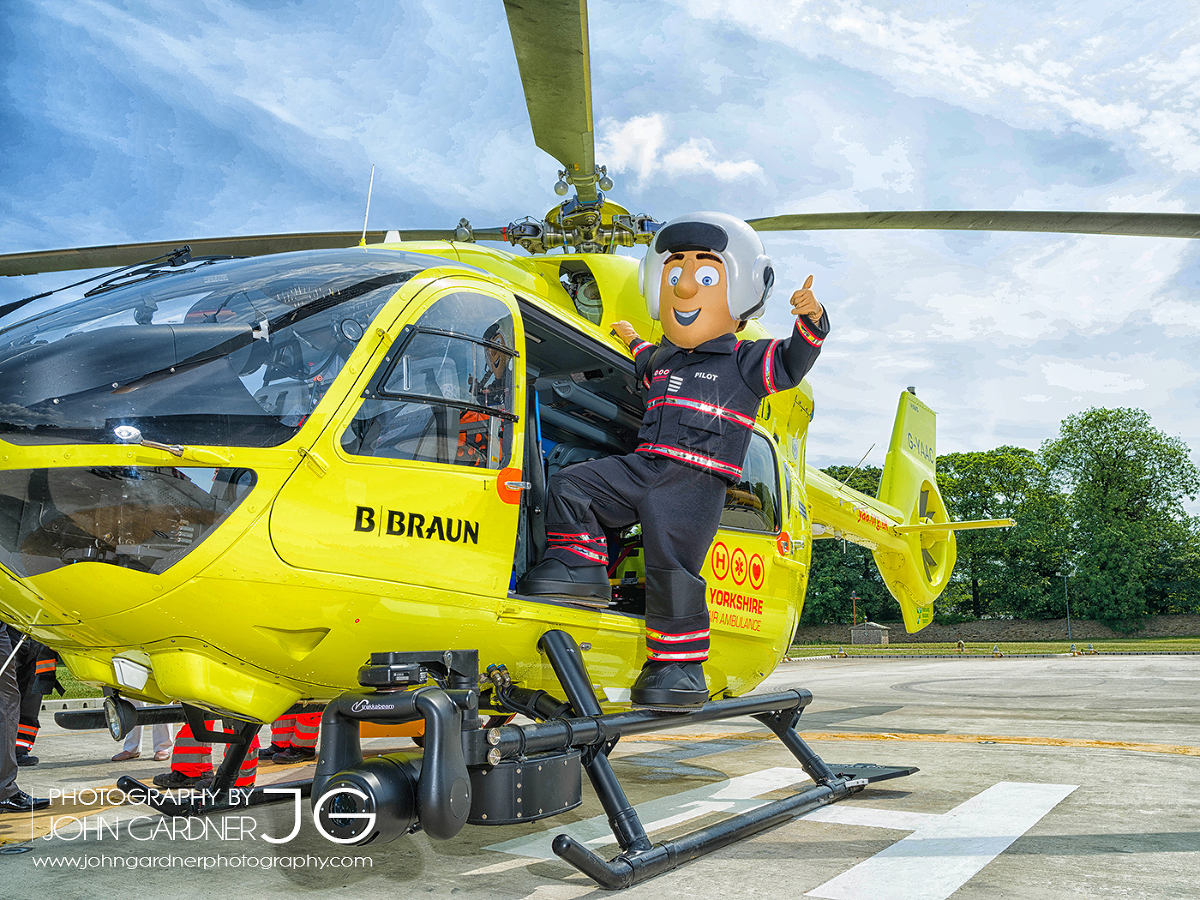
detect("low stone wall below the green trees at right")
[796,614,1200,644]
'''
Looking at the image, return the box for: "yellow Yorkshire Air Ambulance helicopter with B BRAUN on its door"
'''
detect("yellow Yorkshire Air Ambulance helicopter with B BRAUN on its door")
[0,0,1195,877]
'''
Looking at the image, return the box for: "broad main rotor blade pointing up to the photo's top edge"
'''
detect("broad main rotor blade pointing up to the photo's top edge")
[504,0,596,203]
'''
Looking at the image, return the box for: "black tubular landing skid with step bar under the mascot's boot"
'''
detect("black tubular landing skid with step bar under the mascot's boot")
[530,630,868,889]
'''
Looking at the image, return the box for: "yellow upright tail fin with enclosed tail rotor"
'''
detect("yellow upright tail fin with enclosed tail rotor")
[875,391,956,631]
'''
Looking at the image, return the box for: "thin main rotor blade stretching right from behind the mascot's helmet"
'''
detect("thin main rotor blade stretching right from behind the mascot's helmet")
[749,210,1200,238]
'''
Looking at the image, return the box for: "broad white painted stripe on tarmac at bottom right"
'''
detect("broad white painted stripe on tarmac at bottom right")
[805,781,1078,900]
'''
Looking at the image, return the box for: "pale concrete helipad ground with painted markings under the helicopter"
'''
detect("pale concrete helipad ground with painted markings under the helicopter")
[0,656,1200,900]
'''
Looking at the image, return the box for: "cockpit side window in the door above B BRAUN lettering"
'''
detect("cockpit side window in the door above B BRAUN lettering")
[341,292,516,469]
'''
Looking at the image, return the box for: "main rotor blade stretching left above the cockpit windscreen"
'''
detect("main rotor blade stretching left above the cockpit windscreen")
[0,228,468,275]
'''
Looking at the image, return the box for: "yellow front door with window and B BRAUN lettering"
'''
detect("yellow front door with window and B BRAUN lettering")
[271,278,524,596]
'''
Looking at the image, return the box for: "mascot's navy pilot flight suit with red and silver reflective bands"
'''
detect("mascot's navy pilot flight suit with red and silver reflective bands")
[546,314,829,662]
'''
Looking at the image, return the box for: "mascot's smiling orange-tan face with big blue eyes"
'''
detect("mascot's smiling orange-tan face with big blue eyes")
[659,250,738,350]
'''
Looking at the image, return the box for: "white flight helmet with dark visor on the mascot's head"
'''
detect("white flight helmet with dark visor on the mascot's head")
[637,212,775,319]
